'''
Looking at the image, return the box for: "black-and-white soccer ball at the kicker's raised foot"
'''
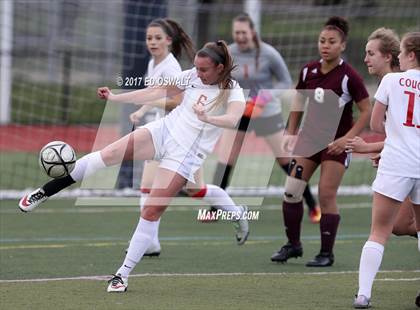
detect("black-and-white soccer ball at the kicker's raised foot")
[39,141,76,178]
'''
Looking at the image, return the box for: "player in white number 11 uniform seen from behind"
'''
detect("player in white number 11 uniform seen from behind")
[353,32,420,309]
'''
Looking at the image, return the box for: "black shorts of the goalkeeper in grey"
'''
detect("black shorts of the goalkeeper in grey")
[238,113,285,137]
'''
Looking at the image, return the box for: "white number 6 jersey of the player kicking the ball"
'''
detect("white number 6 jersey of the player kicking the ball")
[165,68,245,156]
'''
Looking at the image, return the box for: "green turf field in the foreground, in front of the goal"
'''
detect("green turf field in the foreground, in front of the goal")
[0,197,420,309]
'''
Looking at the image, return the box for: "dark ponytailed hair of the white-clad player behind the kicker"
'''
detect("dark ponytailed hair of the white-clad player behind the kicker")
[147,18,195,61]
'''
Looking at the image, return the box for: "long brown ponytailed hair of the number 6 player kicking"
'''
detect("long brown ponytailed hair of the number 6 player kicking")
[197,40,235,107]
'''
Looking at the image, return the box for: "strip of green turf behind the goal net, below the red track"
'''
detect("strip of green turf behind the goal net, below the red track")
[0,152,376,189]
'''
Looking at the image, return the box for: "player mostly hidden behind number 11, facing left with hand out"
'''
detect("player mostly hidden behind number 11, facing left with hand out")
[346,28,420,242]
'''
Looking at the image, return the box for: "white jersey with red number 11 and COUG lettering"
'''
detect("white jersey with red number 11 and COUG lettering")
[375,70,420,179]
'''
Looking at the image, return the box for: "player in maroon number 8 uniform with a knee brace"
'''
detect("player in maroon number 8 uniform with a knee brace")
[271,17,370,267]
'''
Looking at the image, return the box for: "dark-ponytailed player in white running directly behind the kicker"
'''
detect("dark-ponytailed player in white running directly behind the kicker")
[130,18,246,256]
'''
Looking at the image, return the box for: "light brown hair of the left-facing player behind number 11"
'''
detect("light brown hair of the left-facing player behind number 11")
[368,27,400,70]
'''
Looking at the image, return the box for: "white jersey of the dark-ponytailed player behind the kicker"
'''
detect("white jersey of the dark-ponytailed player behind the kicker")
[145,53,182,119]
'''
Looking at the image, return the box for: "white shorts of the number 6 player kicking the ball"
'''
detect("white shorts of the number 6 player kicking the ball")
[142,118,205,183]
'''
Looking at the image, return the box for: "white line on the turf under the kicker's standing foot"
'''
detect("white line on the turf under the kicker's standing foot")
[0,270,420,284]
